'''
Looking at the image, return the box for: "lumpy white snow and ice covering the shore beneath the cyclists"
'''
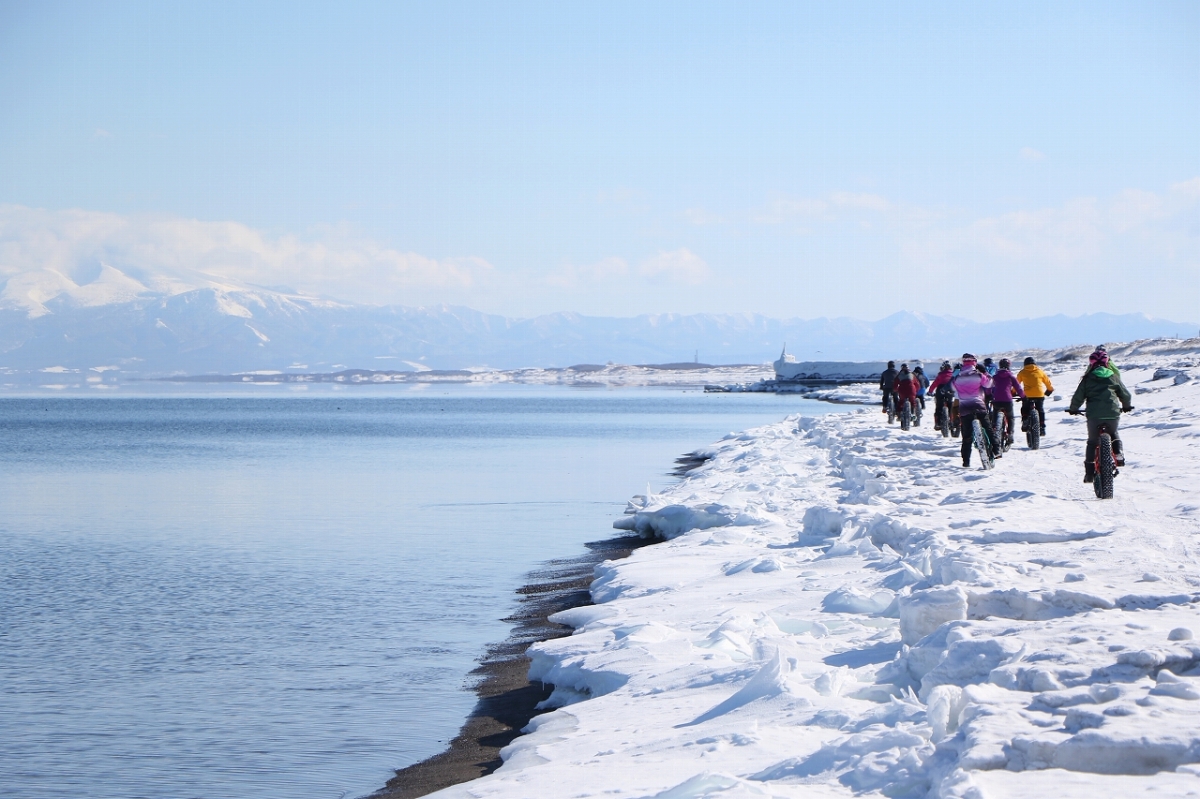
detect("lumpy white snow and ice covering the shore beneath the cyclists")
[437,343,1200,799]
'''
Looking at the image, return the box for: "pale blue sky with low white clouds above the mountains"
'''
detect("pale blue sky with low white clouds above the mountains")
[0,0,1200,322]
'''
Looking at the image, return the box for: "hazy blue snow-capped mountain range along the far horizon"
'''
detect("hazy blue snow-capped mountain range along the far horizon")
[0,265,1196,374]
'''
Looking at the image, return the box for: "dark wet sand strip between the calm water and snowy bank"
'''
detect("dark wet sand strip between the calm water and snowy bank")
[370,527,653,799]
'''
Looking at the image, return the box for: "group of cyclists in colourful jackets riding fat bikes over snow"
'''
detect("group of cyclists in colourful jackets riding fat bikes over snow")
[880,346,1133,482]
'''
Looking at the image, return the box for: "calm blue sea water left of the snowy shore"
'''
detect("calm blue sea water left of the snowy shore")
[0,388,835,799]
